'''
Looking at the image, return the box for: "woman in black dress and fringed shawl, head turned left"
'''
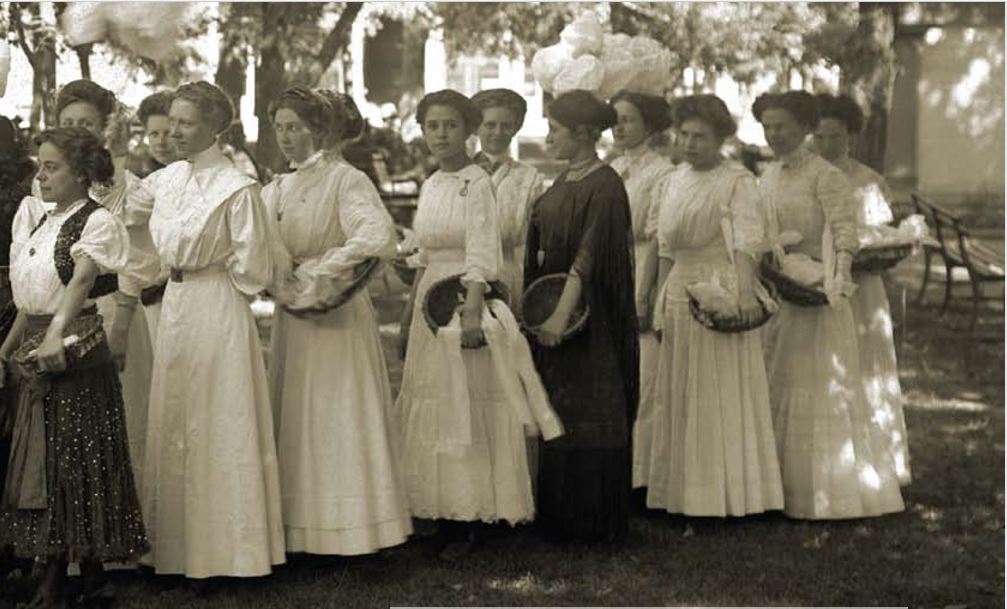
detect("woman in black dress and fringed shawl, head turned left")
[525,91,639,541]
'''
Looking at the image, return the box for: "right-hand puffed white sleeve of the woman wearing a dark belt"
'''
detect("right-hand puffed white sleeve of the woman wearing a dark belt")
[225,184,273,295]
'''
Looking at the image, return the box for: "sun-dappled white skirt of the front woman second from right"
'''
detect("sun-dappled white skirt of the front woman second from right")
[767,301,904,519]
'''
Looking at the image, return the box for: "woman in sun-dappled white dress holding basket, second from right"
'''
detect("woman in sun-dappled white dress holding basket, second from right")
[752,92,904,519]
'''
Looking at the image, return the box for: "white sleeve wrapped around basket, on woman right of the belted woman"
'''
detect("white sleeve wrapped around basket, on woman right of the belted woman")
[294,171,396,303]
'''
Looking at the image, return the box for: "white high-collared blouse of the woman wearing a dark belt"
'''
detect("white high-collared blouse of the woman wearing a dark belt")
[125,145,273,295]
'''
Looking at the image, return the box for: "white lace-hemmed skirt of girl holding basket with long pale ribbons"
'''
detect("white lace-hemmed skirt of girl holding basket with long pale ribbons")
[396,251,535,523]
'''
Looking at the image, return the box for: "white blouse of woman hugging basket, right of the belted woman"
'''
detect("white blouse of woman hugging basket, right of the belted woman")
[263,152,396,307]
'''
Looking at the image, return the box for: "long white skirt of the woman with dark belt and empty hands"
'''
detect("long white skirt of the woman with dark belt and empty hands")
[142,268,285,578]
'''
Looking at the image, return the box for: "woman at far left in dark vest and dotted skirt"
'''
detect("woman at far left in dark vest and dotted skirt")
[0,128,149,607]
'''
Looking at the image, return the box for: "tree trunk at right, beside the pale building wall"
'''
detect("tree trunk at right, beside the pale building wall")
[840,2,899,173]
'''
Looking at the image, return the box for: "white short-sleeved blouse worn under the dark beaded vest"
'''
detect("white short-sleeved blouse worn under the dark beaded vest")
[10,196,129,315]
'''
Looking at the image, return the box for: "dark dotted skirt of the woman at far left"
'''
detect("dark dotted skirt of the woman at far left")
[0,316,149,562]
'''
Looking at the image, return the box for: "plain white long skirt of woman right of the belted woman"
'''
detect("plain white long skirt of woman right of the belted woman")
[270,291,412,556]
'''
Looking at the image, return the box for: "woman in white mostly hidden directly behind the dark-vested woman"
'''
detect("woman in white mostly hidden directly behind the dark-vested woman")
[48,80,154,488]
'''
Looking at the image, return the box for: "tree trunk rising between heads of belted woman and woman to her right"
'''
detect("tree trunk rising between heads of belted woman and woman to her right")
[255,2,287,171]
